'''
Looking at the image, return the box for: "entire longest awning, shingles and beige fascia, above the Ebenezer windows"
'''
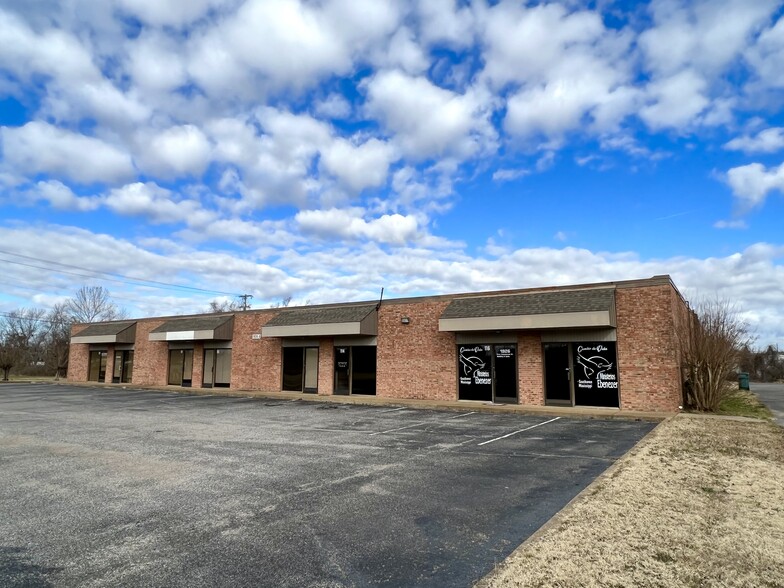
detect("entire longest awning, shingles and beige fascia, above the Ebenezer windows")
[438,288,615,332]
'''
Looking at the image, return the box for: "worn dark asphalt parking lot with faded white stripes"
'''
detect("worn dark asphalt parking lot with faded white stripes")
[0,384,655,587]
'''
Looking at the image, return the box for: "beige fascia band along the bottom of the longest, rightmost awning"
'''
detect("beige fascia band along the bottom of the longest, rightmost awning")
[438,310,615,332]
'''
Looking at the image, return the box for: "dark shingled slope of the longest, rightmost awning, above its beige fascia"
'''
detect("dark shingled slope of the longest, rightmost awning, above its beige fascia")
[441,288,614,319]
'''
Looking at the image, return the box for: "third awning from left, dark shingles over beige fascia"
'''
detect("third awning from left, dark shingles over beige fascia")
[261,304,378,337]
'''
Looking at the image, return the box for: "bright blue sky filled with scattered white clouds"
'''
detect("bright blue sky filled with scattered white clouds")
[0,0,784,348]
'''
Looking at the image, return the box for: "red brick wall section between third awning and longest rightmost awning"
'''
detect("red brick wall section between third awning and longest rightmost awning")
[376,300,457,400]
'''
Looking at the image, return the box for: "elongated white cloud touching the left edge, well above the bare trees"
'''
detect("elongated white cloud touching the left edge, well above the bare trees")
[0,121,134,184]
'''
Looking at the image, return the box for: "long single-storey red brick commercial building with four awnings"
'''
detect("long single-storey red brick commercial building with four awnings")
[68,276,689,411]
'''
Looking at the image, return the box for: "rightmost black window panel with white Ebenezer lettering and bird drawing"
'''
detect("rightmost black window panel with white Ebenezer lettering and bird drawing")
[572,341,618,407]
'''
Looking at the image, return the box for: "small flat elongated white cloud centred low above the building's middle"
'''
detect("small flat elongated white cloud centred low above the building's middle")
[295,208,418,245]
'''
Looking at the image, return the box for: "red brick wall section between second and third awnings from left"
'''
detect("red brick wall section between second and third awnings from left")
[231,310,283,392]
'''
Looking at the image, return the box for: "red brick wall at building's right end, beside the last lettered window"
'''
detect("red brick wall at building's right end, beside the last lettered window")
[615,285,681,411]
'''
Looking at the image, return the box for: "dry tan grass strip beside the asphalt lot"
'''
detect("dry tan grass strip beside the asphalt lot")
[479,415,784,588]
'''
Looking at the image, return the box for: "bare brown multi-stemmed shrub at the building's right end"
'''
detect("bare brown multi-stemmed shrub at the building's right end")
[679,299,750,412]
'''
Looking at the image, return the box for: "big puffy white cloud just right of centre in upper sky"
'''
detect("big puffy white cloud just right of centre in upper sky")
[366,70,497,159]
